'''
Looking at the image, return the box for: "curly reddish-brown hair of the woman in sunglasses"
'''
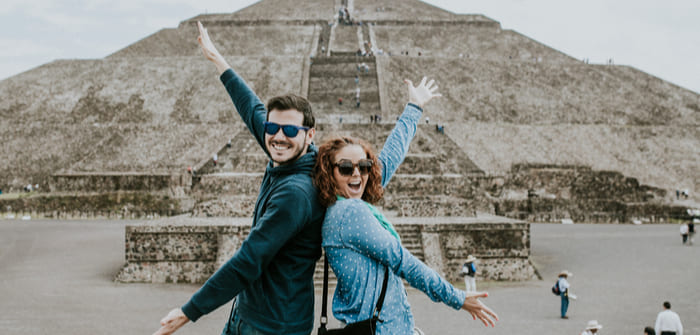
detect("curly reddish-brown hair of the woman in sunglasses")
[314,136,384,207]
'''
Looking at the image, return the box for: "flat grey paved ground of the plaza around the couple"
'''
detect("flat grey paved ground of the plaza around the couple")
[0,220,700,335]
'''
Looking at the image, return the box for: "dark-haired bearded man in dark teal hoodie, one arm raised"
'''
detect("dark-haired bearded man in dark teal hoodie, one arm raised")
[155,22,325,335]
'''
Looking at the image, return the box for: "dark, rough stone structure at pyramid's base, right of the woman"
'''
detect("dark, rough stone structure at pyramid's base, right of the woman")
[485,164,685,223]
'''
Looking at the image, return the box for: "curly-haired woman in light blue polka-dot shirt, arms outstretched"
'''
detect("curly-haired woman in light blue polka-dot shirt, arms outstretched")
[314,78,498,334]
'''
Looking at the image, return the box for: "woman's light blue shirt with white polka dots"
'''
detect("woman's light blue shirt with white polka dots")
[323,104,467,335]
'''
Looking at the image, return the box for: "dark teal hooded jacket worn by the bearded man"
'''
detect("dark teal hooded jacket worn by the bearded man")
[182,69,325,334]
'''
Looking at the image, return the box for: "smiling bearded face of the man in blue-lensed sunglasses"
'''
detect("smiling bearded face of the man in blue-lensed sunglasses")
[265,109,316,166]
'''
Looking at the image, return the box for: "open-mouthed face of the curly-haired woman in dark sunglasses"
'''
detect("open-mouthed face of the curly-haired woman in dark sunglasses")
[333,144,372,199]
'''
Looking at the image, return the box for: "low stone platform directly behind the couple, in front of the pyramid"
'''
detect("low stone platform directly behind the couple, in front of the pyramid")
[116,216,537,283]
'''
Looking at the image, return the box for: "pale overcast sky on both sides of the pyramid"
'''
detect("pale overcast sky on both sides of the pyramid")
[0,0,700,93]
